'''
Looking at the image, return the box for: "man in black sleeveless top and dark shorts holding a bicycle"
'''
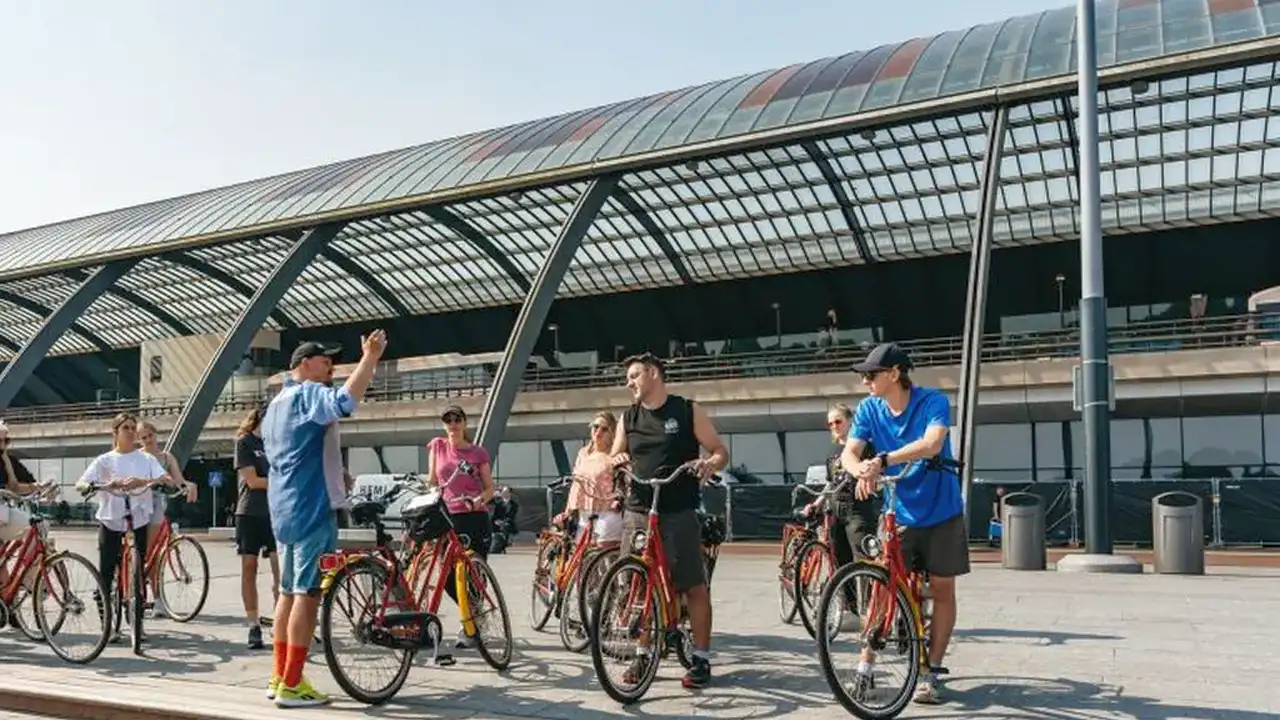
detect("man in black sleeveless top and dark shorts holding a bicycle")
[613,352,728,688]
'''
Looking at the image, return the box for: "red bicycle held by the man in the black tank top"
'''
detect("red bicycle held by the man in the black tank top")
[588,460,724,705]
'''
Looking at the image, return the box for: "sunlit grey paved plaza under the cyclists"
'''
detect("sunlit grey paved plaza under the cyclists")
[0,533,1280,720]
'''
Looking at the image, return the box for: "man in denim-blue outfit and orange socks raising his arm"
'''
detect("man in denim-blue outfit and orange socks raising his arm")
[262,331,387,707]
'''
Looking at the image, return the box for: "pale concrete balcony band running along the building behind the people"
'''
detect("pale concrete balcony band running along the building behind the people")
[10,346,1280,457]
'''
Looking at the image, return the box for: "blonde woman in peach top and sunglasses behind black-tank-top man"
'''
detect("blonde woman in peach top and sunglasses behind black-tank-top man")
[556,411,622,547]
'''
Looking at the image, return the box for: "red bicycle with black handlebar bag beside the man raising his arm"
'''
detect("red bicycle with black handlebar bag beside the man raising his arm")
[320,468,513,705]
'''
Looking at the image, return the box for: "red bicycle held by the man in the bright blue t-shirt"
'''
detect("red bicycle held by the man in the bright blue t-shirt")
[818,461,946,720]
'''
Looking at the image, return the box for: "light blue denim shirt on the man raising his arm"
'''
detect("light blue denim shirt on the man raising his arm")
[262,379,356,543]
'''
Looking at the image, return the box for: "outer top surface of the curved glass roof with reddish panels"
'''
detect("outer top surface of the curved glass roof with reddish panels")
[0,0,1280,277]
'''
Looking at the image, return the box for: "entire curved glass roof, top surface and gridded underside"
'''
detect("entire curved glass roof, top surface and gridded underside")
[0,0,1280,453]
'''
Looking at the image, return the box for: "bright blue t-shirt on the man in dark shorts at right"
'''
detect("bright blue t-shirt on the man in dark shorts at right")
[850,387,964,528]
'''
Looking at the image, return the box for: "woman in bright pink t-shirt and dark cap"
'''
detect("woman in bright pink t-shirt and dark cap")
[426,405,494,648]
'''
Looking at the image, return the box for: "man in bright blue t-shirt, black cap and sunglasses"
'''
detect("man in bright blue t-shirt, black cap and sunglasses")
[841,343,969,705]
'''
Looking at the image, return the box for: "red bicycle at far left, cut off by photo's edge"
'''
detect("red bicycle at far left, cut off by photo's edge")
[0,486,111,664]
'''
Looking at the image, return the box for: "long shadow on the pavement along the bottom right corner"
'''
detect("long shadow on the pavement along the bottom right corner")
[931,678,1276,720]
